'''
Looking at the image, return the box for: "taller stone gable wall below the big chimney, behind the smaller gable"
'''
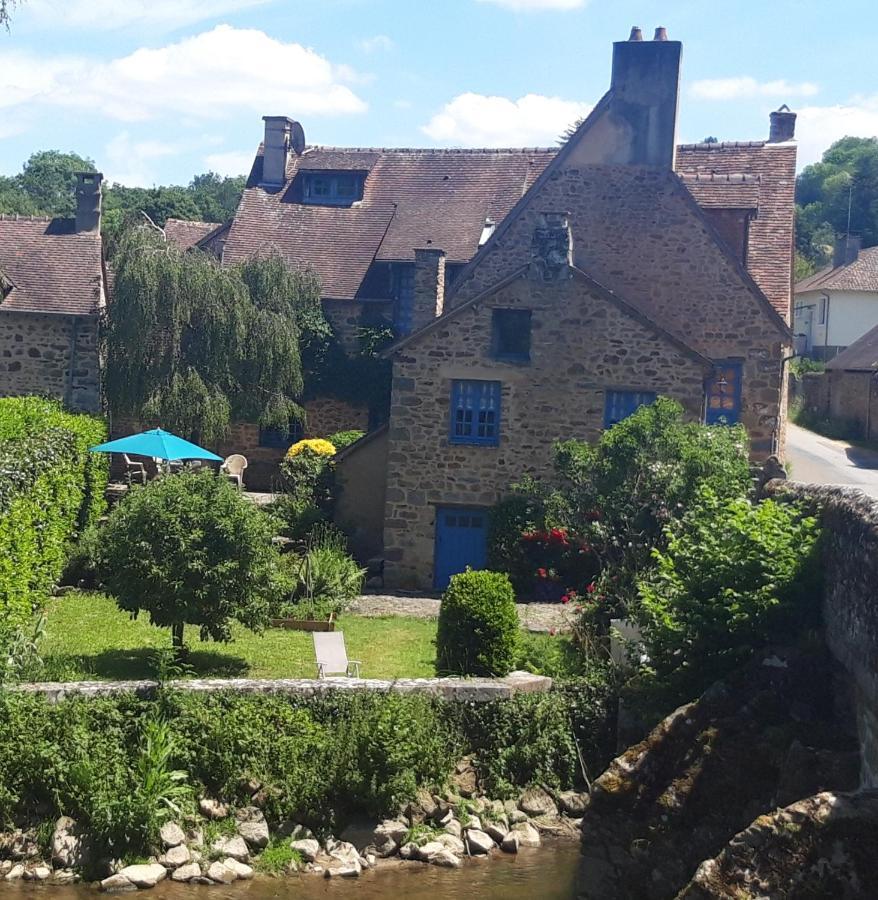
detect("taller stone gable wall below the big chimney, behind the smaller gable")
[454,166,789,458]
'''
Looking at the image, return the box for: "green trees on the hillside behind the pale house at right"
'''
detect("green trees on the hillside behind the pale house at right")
[796,137,878,266]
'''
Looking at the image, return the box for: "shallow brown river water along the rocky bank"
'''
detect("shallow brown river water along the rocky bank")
[4,841,579,900]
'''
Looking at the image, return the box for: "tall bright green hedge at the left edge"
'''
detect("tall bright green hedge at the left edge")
[0,397,108,650]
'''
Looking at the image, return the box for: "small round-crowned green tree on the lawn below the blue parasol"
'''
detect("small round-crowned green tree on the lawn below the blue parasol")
[98,472,281,650]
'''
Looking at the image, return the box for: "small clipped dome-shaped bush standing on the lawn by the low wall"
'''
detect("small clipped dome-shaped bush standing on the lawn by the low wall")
[436,569,519,676]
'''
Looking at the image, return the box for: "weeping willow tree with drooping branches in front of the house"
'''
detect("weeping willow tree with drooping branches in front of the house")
[106,226,330,445]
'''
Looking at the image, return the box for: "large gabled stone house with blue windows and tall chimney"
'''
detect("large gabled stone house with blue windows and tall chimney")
[338,29,795,589]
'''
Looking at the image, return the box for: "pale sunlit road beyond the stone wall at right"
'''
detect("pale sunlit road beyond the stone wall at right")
[787,422,878,497]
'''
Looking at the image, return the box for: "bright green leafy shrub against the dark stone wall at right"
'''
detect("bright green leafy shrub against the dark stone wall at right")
[638,486,821,701]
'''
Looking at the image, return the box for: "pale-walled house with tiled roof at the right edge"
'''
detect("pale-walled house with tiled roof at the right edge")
[793,235,878,360]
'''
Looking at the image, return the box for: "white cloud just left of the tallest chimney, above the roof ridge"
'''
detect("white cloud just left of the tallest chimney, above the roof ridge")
[421,93,591,147]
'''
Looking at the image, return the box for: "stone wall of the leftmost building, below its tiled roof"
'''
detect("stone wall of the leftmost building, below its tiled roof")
[0,312,101,412]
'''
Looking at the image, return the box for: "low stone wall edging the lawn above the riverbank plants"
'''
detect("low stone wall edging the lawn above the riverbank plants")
[10,672,552,703]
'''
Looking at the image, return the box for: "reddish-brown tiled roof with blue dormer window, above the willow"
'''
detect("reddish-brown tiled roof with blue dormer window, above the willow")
[223,147,556,300]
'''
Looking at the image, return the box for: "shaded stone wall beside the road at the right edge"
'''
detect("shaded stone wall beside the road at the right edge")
[766,481,878,788]
